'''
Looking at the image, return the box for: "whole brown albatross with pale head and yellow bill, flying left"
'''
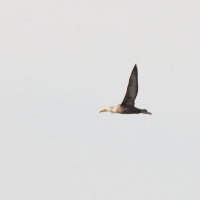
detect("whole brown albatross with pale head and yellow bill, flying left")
[100,65,151,115]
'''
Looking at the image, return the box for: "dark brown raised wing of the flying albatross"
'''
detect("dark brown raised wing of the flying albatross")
[121,65,138,106]
